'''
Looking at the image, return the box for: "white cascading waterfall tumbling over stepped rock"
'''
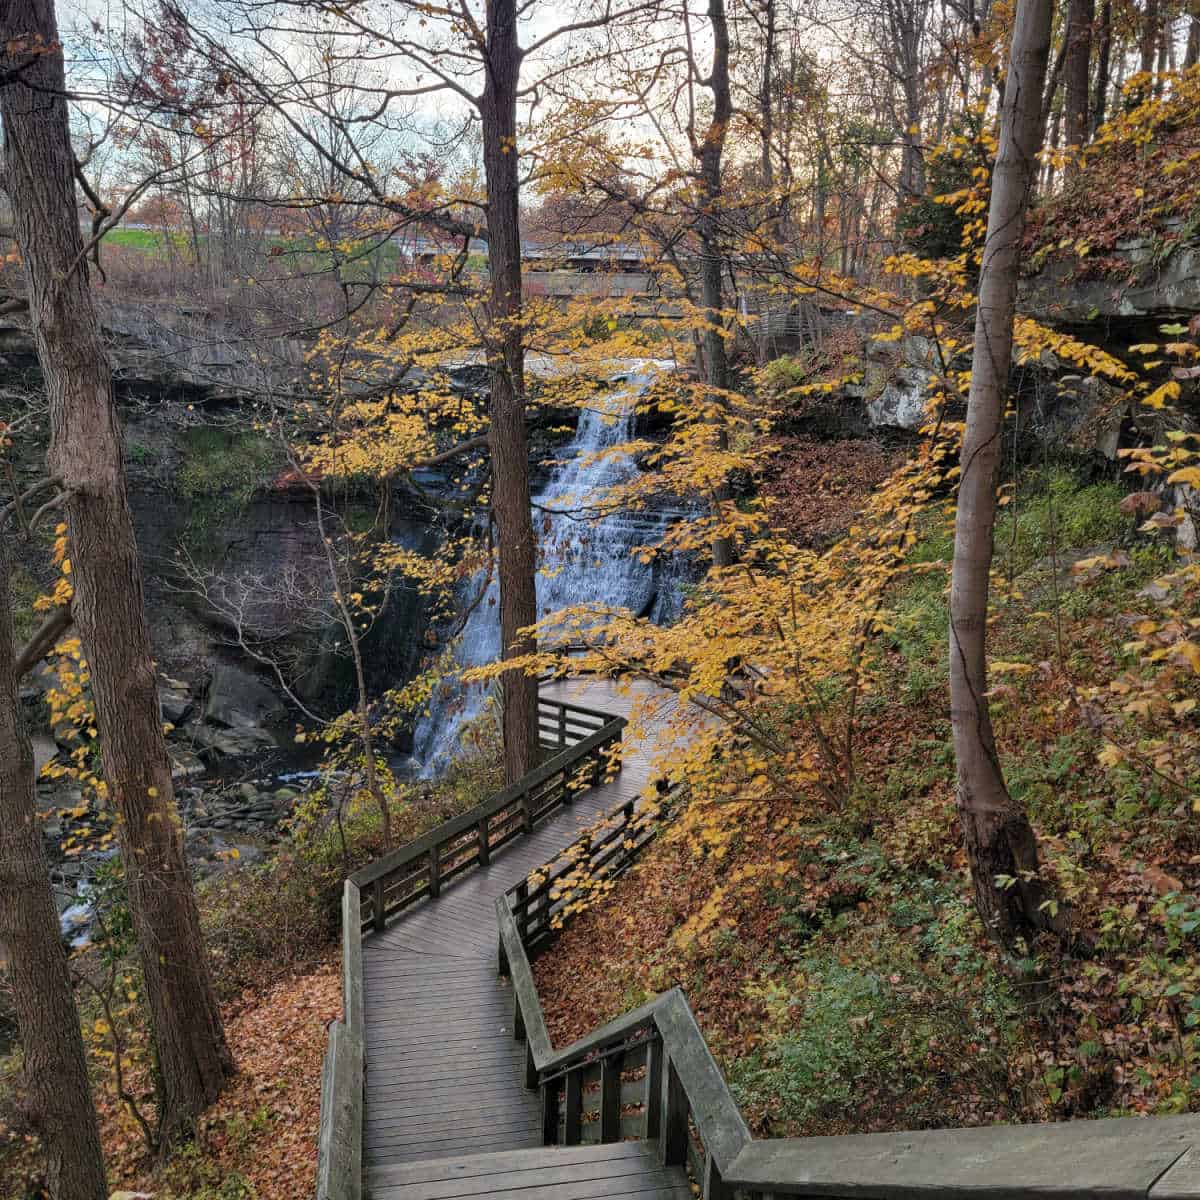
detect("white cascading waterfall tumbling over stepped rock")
[413,364,682,776]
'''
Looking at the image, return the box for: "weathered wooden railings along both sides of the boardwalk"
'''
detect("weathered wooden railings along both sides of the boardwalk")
[317,686,1200,1200]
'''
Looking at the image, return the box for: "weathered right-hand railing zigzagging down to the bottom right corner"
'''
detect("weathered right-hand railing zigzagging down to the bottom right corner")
[496,816,1200,1200]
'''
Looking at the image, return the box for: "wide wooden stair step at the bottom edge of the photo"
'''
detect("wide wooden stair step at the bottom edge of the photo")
[366,1141,691,1200]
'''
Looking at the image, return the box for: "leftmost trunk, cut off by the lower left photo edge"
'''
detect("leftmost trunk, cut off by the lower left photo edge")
[0,532,108,1200]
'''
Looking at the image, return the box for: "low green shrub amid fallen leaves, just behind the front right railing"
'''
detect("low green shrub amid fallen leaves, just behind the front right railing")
[731,907,1016,1135]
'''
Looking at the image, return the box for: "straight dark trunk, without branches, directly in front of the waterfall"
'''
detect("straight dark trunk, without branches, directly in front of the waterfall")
[480,0,538,784]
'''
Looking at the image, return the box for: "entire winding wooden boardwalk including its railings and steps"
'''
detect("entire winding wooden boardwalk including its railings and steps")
[317,679,1200,1200]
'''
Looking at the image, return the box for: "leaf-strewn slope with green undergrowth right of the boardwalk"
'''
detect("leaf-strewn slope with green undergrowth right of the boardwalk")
[536,445,1200,1135]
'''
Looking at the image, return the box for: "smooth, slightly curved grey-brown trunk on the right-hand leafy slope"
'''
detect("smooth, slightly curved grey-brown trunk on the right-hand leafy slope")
[949,0,1052,943]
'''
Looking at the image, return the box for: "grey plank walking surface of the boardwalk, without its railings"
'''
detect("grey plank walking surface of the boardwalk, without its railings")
[362,679,686,1200]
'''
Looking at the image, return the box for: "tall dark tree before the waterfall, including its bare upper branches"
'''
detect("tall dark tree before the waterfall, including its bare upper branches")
[140,0,652,780]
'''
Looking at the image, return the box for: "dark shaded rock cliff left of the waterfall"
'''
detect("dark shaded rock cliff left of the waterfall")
[0,297,446,748]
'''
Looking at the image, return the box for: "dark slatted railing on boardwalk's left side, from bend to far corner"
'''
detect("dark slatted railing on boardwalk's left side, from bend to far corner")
[350,700,625,931]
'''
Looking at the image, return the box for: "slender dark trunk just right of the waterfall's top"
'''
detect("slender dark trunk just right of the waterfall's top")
[697,0,733,566]
